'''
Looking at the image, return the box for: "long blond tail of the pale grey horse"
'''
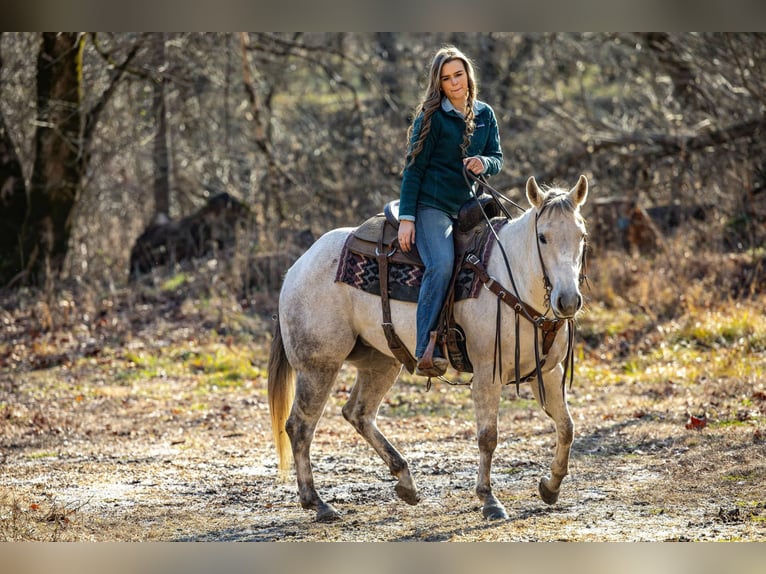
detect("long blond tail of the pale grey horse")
[268,317,295,478]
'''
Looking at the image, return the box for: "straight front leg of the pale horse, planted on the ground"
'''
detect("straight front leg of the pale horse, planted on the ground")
[471,373,508,520]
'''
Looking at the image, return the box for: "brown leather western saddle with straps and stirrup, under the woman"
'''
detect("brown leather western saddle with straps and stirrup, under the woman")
[346,194,500,373]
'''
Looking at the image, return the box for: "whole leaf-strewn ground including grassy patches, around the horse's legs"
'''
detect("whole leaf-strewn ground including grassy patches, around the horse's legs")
[0,286,766,541]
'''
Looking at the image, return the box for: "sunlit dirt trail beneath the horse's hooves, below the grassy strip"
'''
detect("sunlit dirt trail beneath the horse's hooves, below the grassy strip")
[0,340,766,541]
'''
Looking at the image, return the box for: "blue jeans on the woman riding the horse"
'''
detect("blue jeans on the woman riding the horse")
[415,207,455,358]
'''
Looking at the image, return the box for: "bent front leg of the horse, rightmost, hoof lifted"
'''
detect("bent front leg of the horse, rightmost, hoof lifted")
[530,365,574,504]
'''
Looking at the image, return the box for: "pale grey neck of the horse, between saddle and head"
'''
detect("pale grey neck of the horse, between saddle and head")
[487,209,545,312]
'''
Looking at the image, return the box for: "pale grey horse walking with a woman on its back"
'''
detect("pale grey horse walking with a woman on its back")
[268,175,588,522]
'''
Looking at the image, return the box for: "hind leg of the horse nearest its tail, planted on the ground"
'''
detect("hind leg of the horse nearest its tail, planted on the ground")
[285,367,340,522]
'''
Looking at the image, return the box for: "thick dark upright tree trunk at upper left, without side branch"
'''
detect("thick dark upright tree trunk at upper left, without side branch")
[22,32,83,284]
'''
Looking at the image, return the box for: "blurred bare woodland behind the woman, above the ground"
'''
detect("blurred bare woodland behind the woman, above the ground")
[0,33,766,287]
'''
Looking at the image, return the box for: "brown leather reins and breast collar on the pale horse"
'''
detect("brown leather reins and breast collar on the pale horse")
[463,168,586,406]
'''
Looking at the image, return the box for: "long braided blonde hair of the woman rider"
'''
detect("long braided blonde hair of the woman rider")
[407,46,478,166]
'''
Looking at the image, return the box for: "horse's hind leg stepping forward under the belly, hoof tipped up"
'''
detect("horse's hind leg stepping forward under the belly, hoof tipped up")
[343,346,420,504]
